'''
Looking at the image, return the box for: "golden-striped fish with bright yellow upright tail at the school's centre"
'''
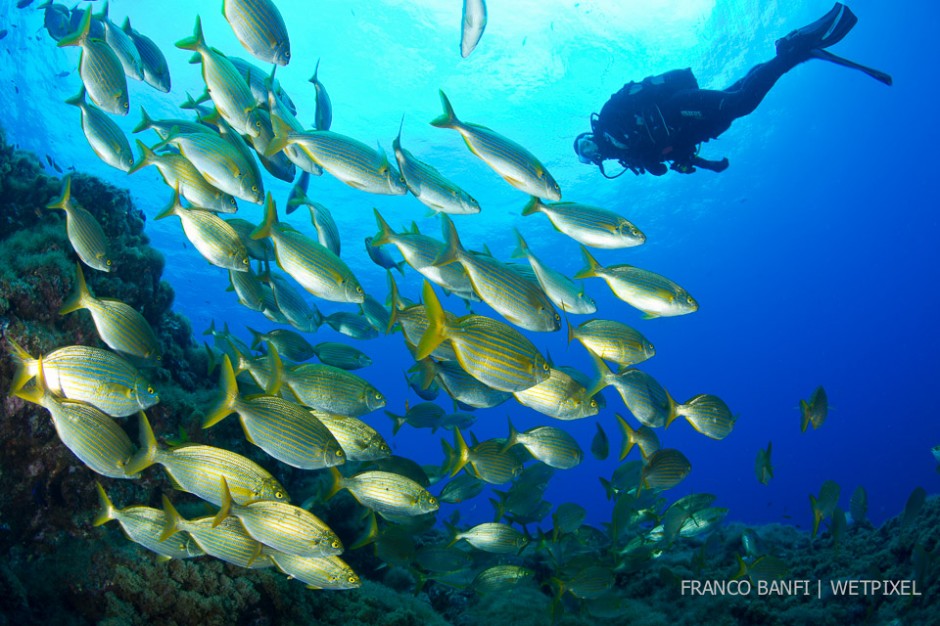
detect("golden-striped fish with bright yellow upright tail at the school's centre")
[416,282,551,392]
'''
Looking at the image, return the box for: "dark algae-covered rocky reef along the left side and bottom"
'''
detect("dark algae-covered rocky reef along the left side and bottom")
[0,131,940,626]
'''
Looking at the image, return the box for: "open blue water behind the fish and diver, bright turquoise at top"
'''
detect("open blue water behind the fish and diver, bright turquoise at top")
[0,0,940,527]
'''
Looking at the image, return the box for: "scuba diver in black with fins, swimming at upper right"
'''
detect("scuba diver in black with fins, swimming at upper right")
[574,2,892,178]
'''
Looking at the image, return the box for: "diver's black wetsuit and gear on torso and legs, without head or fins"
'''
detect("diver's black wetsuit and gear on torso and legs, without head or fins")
[594,54,807,176]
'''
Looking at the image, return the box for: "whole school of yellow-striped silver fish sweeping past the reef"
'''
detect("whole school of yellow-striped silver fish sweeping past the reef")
[12,0,912,615]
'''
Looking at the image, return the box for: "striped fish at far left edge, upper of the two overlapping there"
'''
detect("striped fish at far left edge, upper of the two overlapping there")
[7,336,160,417]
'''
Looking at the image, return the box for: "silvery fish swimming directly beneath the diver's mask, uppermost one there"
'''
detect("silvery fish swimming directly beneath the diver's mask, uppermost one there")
[522,197,646,250]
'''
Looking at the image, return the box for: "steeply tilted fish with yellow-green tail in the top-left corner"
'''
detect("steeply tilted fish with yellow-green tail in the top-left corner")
[58,7,129,115]
